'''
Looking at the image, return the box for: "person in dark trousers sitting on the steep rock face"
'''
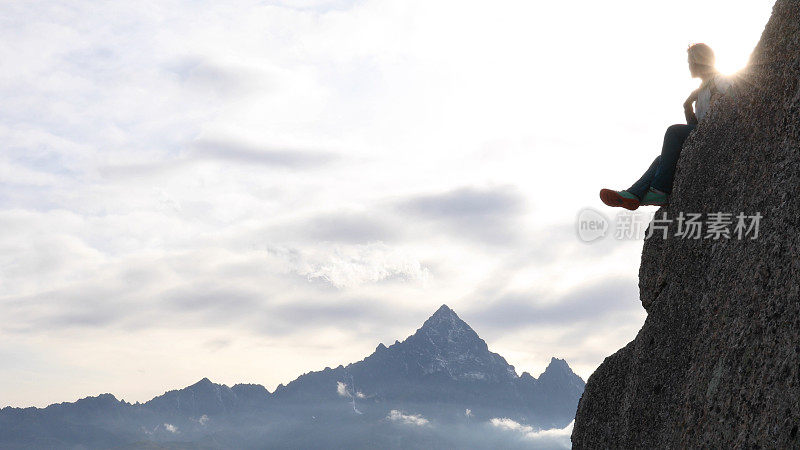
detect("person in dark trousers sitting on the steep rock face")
[600,44,731,210]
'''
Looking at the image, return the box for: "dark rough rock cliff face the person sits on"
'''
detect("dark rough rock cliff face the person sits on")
[572,0,800,448]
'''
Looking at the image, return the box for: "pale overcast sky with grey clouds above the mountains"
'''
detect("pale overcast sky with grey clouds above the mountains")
[0,0,773,406]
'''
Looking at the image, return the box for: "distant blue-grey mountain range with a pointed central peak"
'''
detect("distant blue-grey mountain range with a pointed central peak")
[0,305,584,449]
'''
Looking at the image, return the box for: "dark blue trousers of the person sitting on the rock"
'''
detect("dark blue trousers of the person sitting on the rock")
[628,124,695,200]
